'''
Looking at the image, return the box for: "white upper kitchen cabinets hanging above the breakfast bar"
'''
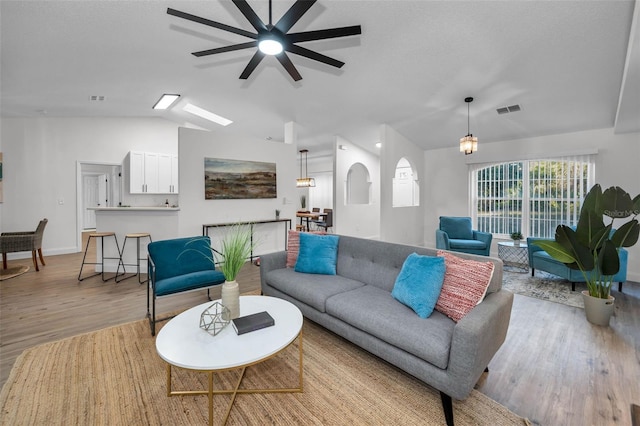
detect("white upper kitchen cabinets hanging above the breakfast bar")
[129,151,178,194]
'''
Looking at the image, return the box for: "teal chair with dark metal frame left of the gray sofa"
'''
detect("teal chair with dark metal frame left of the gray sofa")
[147,236,225,336]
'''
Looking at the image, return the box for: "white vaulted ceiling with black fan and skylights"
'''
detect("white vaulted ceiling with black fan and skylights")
[0,0,640,157]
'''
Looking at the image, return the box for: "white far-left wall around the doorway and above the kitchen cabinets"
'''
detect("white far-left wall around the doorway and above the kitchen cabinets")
[0,117,178,258]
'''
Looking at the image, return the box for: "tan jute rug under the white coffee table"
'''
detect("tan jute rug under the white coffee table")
[0,312,528,426]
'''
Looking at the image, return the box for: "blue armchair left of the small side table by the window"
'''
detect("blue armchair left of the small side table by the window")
[436,216,493,256]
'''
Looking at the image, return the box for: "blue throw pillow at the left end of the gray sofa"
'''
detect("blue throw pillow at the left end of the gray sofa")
[294,232,340,275]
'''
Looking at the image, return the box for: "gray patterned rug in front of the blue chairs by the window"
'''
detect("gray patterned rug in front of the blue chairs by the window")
[502,271,586,309]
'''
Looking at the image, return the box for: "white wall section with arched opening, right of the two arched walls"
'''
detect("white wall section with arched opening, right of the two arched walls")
[380,124,424,245]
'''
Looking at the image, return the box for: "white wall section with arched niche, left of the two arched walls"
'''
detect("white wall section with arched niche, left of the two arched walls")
[333,137,380,239]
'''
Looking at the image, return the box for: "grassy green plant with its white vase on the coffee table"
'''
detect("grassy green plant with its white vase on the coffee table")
[214,224,256,320]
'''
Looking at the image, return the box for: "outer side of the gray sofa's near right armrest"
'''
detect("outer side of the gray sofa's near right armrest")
[446,290,513,399]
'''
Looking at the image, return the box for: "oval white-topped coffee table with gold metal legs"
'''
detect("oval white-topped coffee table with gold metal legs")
[156,296,303,425]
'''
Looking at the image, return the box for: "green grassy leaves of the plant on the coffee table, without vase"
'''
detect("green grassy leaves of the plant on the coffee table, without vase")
[218,225,257,281]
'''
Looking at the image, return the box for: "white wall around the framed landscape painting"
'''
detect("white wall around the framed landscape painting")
[178,128,299,254]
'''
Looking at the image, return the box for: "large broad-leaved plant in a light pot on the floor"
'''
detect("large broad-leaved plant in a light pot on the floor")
[534,184,640,325]
